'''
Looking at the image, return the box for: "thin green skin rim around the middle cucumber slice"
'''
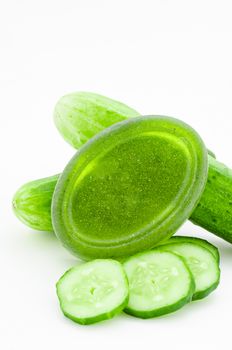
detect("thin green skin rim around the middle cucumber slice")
[124,247,195,319]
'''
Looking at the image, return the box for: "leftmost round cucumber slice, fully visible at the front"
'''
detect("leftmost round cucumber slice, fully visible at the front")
[56,259,128,324]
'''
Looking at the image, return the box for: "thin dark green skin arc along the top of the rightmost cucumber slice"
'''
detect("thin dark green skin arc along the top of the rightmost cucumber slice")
[162,236,220,263]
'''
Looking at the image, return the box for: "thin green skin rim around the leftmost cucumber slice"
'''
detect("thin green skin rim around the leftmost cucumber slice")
[56,259,129,325]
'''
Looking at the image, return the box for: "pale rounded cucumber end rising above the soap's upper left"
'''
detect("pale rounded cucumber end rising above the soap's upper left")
[54,92,139,149]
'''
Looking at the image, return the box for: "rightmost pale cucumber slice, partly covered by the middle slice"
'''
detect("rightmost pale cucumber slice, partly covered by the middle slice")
[159,241,220,300]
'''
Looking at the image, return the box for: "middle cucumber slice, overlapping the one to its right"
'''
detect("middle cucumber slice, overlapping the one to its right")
[123,249,195,318]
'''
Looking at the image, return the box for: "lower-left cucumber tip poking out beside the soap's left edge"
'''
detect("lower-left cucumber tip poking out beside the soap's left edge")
[12,175,59,231]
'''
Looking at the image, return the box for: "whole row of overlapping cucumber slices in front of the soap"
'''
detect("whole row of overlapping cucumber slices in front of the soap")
[57,236,220,324]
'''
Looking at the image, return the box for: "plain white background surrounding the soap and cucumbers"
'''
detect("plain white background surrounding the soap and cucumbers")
[0,0,232,350]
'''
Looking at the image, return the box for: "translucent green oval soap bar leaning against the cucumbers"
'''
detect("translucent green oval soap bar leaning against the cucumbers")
[52,116,208,259]
